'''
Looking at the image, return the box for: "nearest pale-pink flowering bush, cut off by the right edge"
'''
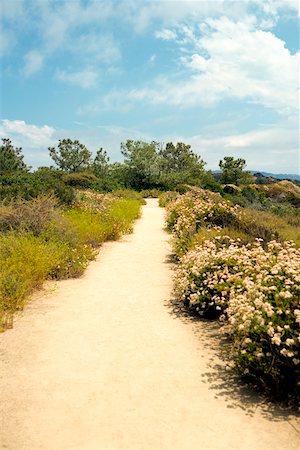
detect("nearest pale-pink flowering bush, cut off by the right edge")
[223,241,300,401]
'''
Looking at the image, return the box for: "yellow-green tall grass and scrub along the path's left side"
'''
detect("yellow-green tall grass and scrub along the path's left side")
[0,194,141,330]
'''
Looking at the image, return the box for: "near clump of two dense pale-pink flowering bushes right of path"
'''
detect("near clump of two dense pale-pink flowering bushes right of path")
[175,237,300,399]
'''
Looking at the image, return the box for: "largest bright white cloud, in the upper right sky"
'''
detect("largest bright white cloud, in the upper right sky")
[113,17,299,115]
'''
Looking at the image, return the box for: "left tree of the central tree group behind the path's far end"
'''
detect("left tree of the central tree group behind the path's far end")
[121,140,159,190]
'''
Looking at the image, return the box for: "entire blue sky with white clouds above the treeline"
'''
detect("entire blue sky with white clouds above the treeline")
[0,0,299,173]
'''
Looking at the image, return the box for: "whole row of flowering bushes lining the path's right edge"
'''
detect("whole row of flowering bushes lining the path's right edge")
[167,190,300,402]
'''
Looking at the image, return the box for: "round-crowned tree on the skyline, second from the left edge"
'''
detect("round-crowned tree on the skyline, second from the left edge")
[49,139,92,172]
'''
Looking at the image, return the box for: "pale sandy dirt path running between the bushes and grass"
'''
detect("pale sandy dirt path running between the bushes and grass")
[0,200,300,450]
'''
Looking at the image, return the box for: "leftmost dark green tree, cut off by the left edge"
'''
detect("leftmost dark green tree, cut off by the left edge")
[0,138,29,174]
